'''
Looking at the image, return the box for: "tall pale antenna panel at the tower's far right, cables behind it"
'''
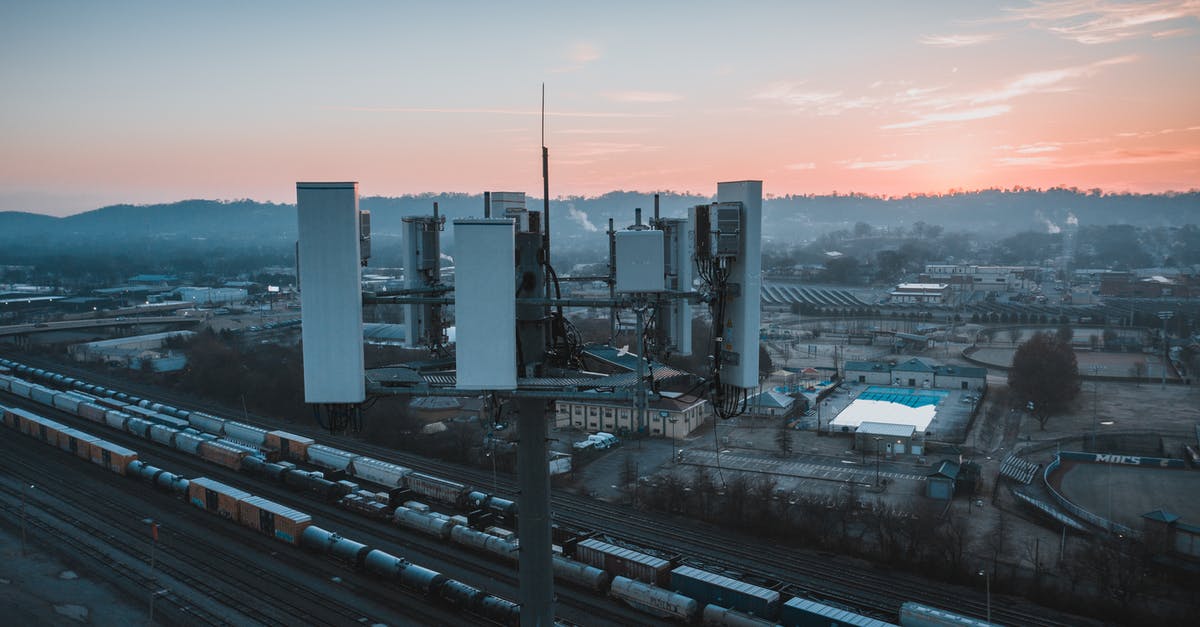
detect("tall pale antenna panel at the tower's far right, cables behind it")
[716,180,762,388]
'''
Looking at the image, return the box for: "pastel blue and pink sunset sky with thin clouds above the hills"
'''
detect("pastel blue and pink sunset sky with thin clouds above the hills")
[0,0,1200,215]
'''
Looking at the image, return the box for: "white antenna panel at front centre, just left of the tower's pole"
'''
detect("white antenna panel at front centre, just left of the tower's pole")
[454,217,517,389]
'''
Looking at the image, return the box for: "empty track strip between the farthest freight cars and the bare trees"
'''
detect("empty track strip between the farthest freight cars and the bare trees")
[2,350,1079,627]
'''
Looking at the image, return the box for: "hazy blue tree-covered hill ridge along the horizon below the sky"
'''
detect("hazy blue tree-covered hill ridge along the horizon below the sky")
[0,189,1200,254]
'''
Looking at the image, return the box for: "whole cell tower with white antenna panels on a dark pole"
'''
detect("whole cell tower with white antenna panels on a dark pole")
[296,172,762,626]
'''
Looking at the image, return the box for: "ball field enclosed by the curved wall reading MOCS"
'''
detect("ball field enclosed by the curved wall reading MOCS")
[1060,464,1200,529]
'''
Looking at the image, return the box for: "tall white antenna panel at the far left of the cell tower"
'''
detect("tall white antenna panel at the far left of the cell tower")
[296,183,366,402]
